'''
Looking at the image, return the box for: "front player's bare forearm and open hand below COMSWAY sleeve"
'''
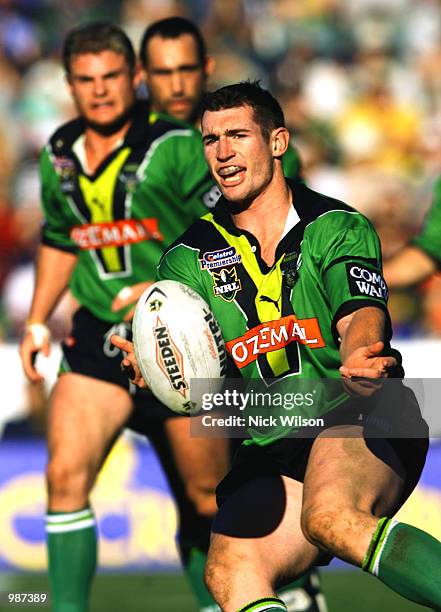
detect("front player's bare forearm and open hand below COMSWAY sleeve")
[337,306,398,395]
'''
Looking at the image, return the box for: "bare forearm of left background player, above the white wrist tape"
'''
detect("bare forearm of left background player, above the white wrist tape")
[28,245,77,323]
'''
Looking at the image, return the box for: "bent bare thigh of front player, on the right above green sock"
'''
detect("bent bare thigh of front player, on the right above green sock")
[303,425,406,516]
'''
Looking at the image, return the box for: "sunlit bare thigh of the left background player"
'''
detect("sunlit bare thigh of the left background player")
[48,372,132,472]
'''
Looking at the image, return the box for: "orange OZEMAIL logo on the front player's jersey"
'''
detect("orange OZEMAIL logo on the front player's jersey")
[226,315,326,368]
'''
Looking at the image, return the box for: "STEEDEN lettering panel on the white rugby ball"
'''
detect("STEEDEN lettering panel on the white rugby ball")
[153,317,188,398]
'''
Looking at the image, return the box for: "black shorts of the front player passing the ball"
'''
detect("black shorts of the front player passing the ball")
[216,388,429,507]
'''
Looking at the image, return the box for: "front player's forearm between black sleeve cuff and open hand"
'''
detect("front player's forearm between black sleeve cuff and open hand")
[337,306,386,363]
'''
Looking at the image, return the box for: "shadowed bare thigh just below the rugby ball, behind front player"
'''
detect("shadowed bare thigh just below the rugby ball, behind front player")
[164,417,229,493]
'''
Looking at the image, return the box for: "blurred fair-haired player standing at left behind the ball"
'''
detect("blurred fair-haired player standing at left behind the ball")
[20,23,228,612]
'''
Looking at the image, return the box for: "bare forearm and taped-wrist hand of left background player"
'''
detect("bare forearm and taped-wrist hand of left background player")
[20,245,77,382]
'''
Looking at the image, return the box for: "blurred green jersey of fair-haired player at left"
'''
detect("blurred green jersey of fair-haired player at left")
[40,102,219,322]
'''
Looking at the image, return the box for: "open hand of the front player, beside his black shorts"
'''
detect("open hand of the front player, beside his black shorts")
[340,341,398,397]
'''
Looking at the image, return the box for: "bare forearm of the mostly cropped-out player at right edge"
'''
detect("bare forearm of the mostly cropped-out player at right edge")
[384,245,436,288]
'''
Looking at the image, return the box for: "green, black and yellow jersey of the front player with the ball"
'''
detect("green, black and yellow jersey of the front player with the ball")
[158,182,389,438]
